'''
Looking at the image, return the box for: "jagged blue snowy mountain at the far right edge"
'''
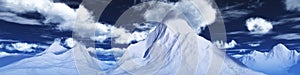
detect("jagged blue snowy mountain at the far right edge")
[235,44,299,75]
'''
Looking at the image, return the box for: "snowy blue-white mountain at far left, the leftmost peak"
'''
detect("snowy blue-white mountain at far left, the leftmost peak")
[0,41,77,75]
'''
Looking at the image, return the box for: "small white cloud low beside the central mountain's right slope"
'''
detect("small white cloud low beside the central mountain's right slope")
[213,40,237,49]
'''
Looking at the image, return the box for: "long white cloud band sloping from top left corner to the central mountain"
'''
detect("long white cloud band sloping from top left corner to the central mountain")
[0,0,152,46]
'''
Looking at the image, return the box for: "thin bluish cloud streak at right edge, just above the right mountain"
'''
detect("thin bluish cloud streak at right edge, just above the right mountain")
[273,33,300,40]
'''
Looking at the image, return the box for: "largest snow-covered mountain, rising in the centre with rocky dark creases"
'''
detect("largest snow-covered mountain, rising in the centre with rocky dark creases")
[107,19,261,75]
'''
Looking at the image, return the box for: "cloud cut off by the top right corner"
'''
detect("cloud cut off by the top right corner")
[285,0,300,11]
